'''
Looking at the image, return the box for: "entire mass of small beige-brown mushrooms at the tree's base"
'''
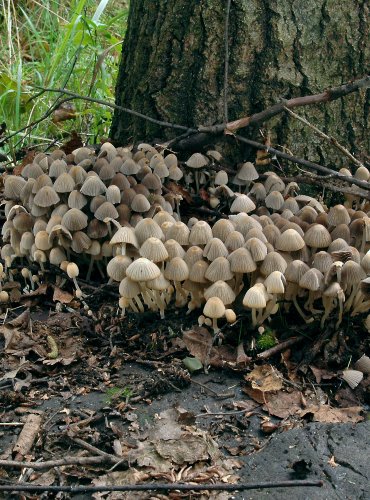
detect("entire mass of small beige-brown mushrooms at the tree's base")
[1,143,370,332]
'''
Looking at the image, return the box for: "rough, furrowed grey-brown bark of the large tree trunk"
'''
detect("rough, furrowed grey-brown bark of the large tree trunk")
[111,0,369,166]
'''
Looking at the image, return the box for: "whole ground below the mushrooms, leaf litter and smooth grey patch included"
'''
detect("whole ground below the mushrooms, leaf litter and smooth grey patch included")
[0,282,370,499]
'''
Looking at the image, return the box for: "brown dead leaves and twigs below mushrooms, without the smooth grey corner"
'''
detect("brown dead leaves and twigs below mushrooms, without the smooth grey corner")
[0,285,369,492]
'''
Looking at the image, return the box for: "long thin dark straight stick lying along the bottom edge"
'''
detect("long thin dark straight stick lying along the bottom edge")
[0,480,324,493]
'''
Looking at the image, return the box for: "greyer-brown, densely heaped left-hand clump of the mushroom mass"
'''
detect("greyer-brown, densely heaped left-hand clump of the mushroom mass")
[1,143,183,277]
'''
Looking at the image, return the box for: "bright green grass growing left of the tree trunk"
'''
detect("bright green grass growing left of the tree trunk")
[0,0,128,161]
